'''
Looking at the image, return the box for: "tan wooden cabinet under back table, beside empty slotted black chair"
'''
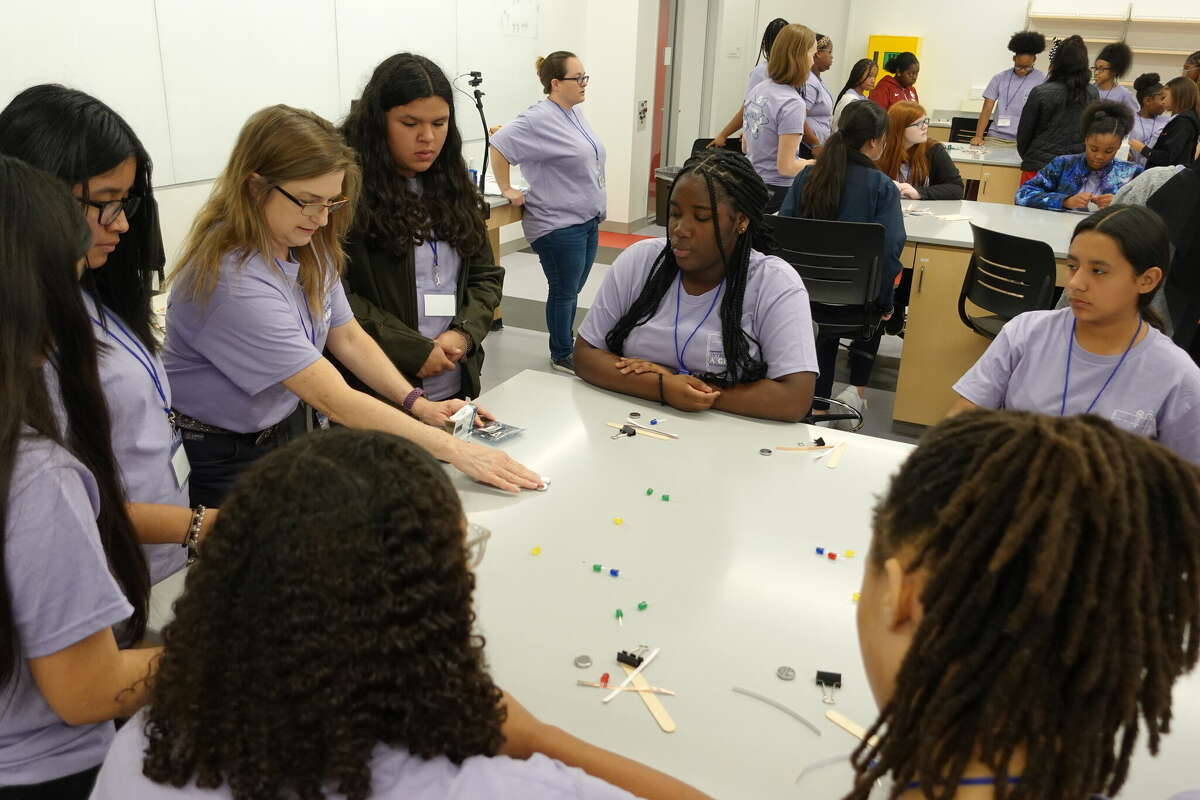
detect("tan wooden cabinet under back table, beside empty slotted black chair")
[893,245,989,425]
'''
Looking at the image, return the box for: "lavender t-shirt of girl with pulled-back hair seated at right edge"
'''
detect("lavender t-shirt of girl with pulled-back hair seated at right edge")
[954,308,1200,464]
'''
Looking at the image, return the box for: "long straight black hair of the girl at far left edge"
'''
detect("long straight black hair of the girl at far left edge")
[0,155,150,687]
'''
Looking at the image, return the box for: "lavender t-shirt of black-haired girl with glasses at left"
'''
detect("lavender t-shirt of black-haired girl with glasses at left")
[83,291,190,583]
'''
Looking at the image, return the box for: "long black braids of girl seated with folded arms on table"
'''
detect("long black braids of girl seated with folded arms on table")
[605,150,773,386]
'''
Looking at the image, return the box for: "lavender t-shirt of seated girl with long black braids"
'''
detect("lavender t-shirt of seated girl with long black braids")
[580,239,817,379]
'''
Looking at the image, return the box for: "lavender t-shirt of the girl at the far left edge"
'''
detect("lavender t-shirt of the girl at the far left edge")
[0,428,133,786]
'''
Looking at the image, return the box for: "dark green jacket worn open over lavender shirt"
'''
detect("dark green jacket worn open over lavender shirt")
[342,239,504,397]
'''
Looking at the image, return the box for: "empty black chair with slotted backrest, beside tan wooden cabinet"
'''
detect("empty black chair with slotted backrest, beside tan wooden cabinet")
[959,223,1056,338]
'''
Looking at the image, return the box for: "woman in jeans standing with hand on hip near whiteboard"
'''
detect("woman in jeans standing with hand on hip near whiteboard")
[492,50,607,375]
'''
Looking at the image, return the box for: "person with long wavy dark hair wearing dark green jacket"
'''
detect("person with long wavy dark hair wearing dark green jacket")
[342,53,504,401]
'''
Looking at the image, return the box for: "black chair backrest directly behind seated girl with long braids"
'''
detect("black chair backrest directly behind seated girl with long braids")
[767,217,884,332]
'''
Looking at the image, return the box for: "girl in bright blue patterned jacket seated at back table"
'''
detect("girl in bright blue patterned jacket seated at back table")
[1014,100,1141,211]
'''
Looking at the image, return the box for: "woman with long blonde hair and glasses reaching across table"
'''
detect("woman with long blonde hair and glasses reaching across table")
[164,106,540,505]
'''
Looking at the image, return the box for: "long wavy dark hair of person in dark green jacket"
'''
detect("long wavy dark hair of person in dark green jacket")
[342,53,487,258]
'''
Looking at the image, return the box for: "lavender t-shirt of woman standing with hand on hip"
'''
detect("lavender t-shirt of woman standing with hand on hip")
[492,100,608,241]
